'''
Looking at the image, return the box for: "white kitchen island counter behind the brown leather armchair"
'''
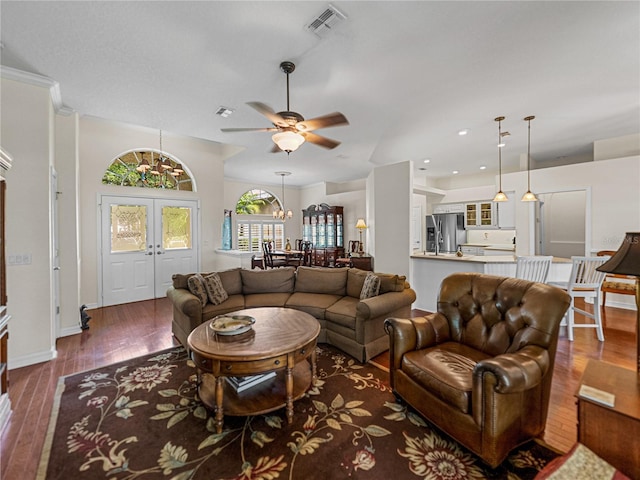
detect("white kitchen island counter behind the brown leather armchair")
[411,253,571,312]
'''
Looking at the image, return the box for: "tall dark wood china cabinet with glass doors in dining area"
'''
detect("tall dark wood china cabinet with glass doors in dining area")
[302,203,344,267]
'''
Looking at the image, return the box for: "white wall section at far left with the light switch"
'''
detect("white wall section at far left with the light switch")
[0,78,55,368]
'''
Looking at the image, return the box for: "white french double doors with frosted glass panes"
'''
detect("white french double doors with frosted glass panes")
[100,195,199,306]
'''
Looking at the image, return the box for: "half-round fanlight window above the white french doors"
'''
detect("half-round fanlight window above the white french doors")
[102,150,193,191]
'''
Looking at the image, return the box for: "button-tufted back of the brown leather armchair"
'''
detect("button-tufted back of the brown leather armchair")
[438,274,559,356]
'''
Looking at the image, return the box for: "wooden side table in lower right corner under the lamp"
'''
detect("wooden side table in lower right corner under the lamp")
[576,360,640,478]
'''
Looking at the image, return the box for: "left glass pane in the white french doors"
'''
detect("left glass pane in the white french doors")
[111,205,147,253]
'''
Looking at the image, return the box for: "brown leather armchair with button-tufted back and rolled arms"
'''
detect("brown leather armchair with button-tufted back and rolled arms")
[385,273,569,467]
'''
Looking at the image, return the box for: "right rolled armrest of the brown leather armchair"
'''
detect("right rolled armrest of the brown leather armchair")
[473,345,550,394]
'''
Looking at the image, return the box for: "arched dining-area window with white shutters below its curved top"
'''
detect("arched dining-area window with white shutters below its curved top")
[236,189,284,253]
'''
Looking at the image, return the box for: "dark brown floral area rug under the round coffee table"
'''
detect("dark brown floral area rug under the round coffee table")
[38,345,558,480]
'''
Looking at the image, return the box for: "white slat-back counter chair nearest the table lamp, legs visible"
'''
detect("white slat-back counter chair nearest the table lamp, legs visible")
[549,256,611,342]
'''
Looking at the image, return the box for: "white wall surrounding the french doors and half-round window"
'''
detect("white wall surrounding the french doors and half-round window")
[79,117,237,305]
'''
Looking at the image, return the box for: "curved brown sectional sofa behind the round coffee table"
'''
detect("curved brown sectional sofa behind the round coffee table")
[167,267,416,362]
